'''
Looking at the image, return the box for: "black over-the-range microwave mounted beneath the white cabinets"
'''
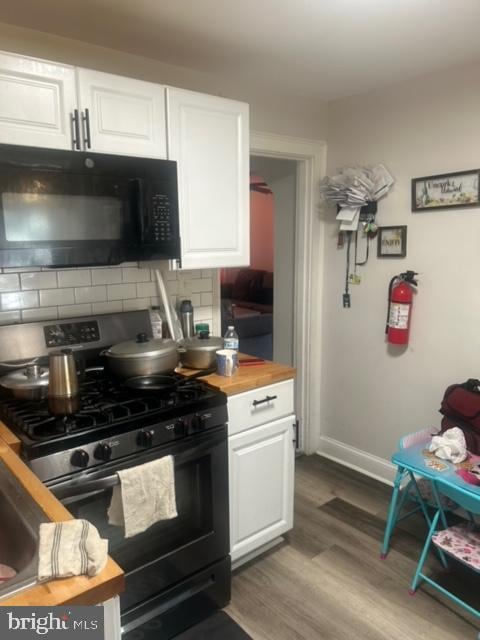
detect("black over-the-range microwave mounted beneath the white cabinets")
[0,145,180,267]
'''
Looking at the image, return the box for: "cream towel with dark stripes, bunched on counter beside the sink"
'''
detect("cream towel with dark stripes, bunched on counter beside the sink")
[38,520,108,582]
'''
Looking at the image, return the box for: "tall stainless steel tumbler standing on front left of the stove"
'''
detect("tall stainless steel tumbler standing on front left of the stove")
[47,349,80,415]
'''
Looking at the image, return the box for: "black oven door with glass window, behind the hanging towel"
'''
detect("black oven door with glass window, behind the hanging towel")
[49,427,229,614]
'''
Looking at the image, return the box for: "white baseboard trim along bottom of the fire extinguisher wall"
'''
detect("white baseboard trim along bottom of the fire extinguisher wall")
[317,436,395,485]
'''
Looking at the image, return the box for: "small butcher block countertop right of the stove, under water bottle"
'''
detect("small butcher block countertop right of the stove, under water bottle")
[177,353,296,396]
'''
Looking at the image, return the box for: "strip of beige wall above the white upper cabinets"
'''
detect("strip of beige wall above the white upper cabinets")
[0,21,327,139]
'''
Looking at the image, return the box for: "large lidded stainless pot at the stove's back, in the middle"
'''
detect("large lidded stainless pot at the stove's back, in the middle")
[104,333,178,378]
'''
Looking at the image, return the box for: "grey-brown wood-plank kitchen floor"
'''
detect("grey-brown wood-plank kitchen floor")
[227,455,480,640]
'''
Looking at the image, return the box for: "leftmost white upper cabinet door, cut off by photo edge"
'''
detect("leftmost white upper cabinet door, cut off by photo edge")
[0,53,76,149]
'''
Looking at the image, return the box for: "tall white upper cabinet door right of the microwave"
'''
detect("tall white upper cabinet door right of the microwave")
[167,88,250,269]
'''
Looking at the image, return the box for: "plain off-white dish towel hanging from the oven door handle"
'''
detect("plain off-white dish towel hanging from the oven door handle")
[108,456,178,538]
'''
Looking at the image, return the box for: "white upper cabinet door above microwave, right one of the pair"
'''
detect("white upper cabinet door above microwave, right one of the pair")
[77,69,167,158]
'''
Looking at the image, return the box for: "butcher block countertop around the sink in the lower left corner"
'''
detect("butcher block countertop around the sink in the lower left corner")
[0,436,124,607]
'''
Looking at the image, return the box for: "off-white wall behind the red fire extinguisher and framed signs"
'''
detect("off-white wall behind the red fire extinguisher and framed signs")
[320,60,480,480]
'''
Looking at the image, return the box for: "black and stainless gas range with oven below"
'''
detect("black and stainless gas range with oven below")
[0,312,230,640]
